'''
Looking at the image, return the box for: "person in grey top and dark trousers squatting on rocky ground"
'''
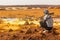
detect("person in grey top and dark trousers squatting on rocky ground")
[40,10,53,33]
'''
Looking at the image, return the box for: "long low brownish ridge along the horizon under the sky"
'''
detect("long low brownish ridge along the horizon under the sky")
[0,5,60,8]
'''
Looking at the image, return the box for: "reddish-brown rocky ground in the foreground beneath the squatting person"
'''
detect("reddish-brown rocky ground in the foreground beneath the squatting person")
[0,28,60,40]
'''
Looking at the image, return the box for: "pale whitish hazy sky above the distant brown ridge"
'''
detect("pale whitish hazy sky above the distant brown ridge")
[0,0,60,5]
